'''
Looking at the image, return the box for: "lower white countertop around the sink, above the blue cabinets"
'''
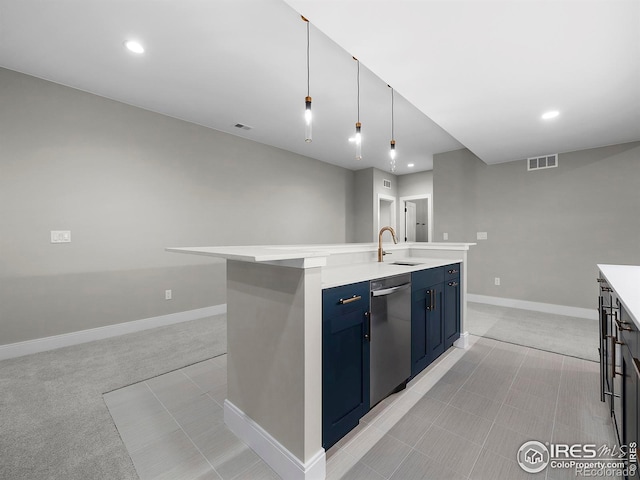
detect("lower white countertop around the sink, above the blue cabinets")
[322,257,462,288]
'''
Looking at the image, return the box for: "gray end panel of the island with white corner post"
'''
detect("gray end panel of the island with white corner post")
[227,260,323,464]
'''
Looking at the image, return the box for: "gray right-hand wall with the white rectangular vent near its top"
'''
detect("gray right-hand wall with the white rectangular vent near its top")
[433,142,640,308]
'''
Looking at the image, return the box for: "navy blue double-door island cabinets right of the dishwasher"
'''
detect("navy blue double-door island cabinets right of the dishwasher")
[411,263,461,377]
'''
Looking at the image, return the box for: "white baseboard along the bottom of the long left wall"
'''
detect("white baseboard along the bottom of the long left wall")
[0,304,227,360]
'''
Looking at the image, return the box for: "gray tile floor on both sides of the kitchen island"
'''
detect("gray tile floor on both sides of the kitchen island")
[104,337,614,480]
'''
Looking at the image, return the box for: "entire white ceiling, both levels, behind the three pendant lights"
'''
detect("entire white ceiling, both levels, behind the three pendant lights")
[0,0,640,174]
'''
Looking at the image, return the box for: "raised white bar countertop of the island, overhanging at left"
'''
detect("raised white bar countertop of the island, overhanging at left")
[166,242,475,266]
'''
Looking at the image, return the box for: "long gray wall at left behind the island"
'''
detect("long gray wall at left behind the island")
[0,69,354,344]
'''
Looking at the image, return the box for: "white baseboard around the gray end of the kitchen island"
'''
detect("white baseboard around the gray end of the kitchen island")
[224,399,326,480]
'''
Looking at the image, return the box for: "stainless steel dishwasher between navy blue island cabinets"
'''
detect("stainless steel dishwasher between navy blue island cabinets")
[369,274,411,407]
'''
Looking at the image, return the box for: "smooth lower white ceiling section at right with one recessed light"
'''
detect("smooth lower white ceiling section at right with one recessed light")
[285,0,640,163]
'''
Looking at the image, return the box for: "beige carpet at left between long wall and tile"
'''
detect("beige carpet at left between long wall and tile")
[0,315,227,480]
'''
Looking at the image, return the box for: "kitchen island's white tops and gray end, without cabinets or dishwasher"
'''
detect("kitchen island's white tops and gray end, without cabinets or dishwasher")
[167,243,473,479]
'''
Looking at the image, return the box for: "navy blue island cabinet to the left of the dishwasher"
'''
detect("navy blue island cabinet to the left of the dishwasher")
[322,282,370,449]
